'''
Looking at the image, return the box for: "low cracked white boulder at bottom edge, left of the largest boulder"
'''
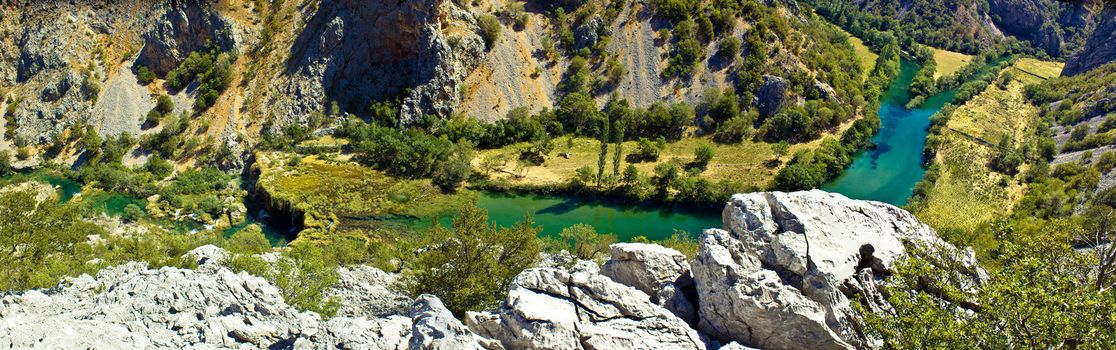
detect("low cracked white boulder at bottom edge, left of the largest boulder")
[468,264,705,349]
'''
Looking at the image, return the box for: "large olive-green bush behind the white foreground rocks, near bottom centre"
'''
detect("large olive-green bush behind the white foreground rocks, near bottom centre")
[404,205,540,315]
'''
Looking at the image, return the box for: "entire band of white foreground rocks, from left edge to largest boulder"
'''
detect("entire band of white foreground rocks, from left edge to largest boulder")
[0,191,987,349]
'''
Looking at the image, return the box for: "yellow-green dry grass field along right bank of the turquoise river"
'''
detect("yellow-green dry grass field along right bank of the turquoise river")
[915,59,1060,248]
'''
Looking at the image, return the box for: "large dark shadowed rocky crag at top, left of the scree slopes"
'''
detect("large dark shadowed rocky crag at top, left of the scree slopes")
[271,0,484,124]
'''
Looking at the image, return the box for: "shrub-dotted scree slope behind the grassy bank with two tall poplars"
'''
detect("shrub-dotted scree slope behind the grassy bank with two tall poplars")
[460,1,860,120]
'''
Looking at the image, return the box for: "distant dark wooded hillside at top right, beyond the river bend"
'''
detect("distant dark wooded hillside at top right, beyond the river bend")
[811,0,1099,57]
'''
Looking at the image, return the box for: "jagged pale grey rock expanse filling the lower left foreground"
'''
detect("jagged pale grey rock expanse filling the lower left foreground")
[0,245,480,349]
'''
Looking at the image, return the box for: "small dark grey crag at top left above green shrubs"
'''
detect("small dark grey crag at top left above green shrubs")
[136,1,237,75]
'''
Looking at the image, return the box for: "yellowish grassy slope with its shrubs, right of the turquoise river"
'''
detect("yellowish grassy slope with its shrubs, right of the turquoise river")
[912,58,1061,248]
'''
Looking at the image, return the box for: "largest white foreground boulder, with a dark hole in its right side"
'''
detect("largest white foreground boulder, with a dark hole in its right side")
[692,191,985,349]
